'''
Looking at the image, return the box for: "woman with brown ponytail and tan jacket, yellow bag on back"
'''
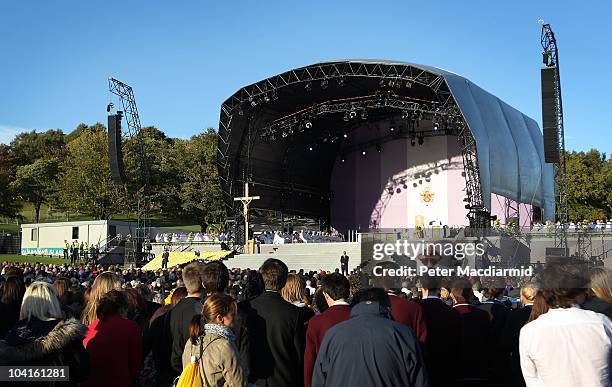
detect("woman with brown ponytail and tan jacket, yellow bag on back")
[182,293,247,386]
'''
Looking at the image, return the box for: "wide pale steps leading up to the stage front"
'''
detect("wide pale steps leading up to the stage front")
[225,242,361,271]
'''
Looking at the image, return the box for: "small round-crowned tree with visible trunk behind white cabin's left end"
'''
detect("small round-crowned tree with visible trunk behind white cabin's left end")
[11,158,58,223]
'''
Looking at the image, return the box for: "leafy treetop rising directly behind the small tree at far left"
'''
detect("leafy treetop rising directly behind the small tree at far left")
[11,129,66,165]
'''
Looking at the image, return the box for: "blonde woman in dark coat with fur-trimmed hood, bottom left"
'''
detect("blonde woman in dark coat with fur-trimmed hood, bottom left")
[0,281,89,385]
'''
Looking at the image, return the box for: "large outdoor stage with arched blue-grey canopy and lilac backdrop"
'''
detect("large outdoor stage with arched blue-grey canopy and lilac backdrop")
[217,60,555,249]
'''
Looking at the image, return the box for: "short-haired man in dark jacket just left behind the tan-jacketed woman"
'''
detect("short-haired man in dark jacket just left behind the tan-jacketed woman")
[170,262,204,374]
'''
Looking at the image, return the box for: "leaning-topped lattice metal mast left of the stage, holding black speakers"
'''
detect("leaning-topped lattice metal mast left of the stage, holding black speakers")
[108,77,151,246]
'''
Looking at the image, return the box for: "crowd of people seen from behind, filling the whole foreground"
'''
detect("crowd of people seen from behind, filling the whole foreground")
[0,259,612,387]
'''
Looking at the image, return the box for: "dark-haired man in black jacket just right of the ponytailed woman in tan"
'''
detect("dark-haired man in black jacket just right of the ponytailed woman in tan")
[248,258,306,387]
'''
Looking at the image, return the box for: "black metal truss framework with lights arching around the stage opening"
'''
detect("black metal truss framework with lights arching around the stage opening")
[217,62,490,244]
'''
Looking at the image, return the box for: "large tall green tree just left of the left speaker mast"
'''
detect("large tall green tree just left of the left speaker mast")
[55,124,126,219]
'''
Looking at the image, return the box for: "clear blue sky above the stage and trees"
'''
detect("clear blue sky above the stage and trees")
[0,0,612,154]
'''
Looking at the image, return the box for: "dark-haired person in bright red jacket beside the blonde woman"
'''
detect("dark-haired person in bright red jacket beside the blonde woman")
[83,290,142,387]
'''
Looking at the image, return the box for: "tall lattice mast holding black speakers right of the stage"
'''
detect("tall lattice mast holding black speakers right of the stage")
[540,21,568,251]
